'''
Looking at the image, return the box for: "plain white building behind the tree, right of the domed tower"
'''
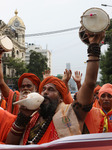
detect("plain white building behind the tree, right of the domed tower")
[25,43,52,72]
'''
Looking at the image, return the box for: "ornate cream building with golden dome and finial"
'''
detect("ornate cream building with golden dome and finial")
[0,10,26,77]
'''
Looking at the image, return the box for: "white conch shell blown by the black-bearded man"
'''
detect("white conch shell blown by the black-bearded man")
[13,92,44,110]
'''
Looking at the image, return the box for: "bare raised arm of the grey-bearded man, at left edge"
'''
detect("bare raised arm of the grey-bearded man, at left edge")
[0,47,10,97]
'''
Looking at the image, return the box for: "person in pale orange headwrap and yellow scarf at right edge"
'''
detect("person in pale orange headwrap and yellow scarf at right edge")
[85,83,112,133]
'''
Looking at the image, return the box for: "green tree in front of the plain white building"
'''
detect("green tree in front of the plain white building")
[27,50,49,80]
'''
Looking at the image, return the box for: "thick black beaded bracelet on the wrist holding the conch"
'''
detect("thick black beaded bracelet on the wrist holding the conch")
[15,112,31,127]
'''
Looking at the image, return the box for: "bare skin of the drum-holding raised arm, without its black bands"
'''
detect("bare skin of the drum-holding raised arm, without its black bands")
[73,33,104,130]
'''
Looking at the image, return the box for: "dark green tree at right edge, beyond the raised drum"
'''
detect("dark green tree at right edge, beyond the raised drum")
[100,19,112,84]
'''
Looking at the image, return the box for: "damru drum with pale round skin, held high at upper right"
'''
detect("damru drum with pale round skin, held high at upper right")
[79,8,110,45]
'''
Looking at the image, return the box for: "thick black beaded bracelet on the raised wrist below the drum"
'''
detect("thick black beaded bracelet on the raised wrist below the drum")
[87,43,101,57]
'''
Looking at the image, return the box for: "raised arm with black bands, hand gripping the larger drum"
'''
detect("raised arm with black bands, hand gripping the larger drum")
[73,33,104,121]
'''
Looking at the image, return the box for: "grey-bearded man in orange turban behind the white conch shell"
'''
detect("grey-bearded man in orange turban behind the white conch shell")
[0,48,40,115]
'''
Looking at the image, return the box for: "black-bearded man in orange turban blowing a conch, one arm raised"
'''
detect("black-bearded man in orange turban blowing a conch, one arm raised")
[6,33,104,145]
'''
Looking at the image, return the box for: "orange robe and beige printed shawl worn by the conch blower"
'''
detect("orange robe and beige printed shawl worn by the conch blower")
[21,102,81,145]
